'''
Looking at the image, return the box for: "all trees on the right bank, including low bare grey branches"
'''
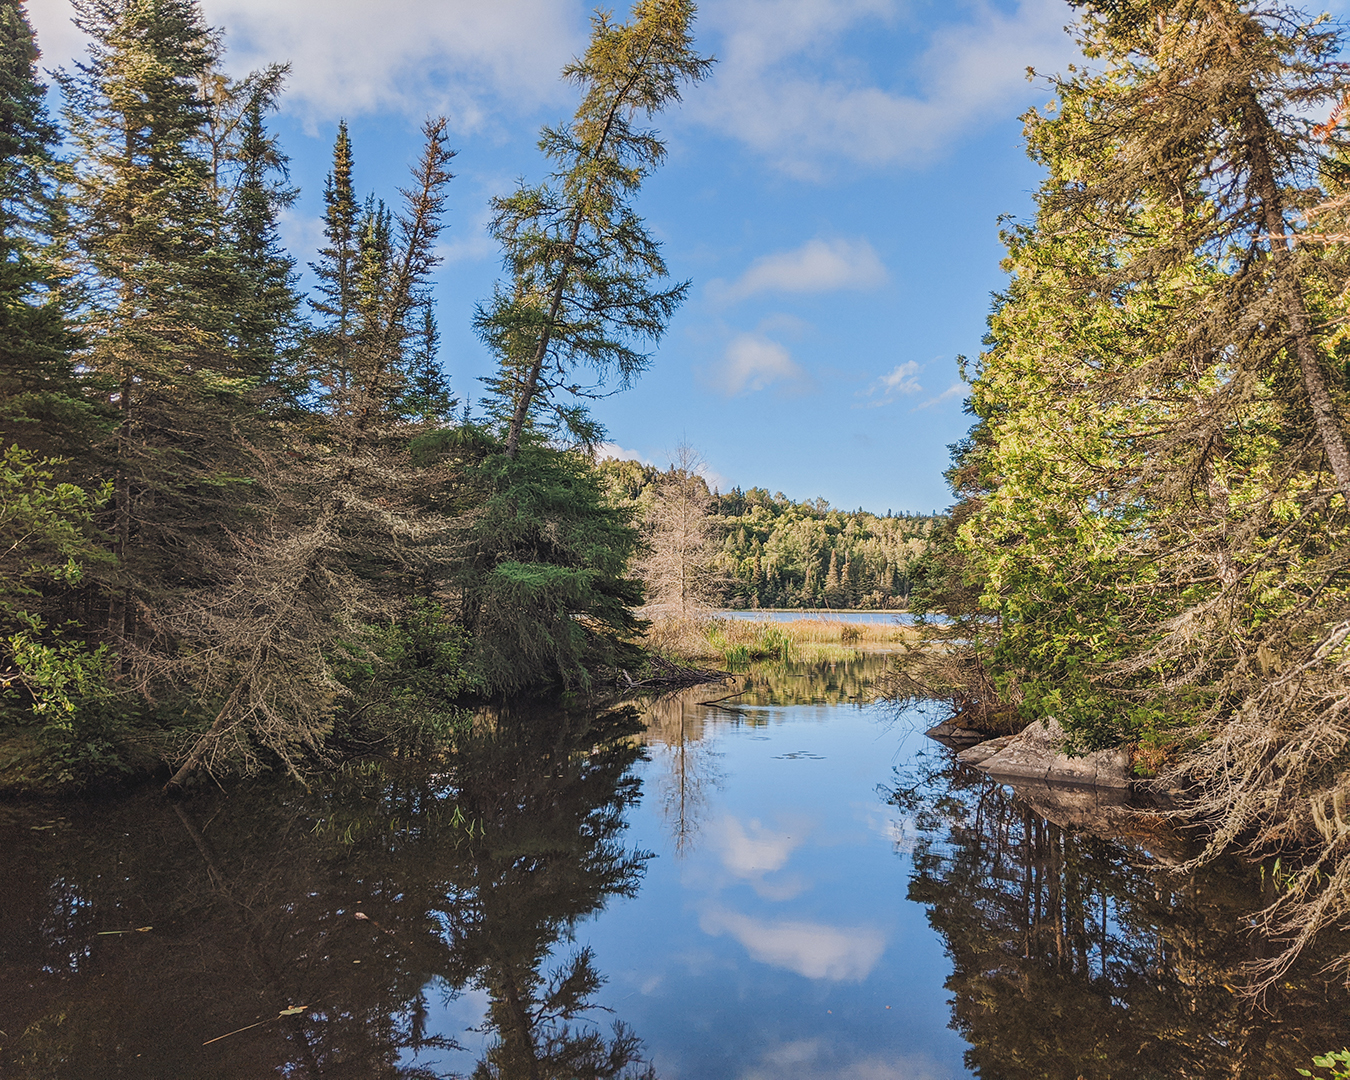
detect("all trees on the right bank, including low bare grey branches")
[911,0,1350,986]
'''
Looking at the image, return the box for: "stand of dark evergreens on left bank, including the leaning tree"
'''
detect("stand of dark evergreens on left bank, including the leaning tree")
[0,0,710,791]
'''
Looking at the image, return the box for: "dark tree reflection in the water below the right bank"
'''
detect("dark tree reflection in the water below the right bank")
[894,759,1350,1080]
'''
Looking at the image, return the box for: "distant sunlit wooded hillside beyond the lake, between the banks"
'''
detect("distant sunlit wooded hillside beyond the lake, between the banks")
[599,460,937,610]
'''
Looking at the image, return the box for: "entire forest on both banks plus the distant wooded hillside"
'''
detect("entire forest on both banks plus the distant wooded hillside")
[0,0,1350,980]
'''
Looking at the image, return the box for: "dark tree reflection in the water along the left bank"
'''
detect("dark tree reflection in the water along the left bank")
[0,711,647,1080]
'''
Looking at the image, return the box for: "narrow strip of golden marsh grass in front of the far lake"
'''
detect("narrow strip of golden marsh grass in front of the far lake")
[644,618,914,671]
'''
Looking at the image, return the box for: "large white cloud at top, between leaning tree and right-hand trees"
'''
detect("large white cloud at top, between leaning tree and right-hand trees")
[690,0,1075,178]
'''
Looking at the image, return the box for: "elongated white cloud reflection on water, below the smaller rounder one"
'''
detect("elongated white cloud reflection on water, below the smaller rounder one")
[699,910,886,983]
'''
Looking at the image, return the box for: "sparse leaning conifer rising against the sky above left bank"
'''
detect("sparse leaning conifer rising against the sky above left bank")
[475,0,711,458]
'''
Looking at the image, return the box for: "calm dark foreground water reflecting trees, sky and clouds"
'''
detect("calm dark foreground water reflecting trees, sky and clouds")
[0,657,1350,1080]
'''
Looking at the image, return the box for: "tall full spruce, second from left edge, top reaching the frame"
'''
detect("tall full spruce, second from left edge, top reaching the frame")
[58,0,258,656]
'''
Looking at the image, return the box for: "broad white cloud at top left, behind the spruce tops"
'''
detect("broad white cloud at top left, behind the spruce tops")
[28,0,587,131]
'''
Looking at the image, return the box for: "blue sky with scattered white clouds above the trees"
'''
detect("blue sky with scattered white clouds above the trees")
[28,0,1117,513]
